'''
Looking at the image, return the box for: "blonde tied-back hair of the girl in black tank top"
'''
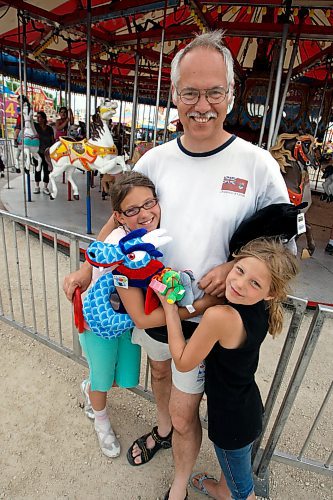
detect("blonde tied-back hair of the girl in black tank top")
[234,238,299,337]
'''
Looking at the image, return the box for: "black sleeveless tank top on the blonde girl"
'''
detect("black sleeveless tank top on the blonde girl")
[205,301,268,450]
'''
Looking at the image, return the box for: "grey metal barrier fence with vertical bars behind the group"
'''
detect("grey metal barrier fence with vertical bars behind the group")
[0,211,333,497]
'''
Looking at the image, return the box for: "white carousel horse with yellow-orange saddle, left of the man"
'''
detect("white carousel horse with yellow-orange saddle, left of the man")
[49,99,128,200]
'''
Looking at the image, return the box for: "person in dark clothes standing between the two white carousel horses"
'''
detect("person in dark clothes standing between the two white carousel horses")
[34,111,54,194]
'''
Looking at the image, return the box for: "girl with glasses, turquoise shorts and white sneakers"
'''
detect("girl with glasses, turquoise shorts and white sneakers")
[79,172,213,458]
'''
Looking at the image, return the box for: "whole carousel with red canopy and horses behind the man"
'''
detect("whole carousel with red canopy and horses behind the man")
[0,0,333,296]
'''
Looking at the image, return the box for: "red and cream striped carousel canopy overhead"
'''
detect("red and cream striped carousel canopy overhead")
[0,0,333,103]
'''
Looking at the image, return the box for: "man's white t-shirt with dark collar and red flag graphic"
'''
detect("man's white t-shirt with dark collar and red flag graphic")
[135,136,289,308]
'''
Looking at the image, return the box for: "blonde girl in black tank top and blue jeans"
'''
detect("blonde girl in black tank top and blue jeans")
[159,239,298,500]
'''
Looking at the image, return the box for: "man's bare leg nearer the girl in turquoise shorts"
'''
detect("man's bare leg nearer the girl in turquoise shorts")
[132,359,171,464]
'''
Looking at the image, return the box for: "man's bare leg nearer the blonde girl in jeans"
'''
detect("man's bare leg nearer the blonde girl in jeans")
[169,386,202,500]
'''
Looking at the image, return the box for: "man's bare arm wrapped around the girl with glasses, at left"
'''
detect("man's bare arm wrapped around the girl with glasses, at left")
[62,215,116,302]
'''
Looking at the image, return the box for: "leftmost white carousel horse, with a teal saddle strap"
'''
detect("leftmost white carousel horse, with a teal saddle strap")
[15,99,42,173]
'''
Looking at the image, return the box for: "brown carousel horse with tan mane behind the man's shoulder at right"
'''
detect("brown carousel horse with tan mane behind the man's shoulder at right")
[269,134,319,259]
